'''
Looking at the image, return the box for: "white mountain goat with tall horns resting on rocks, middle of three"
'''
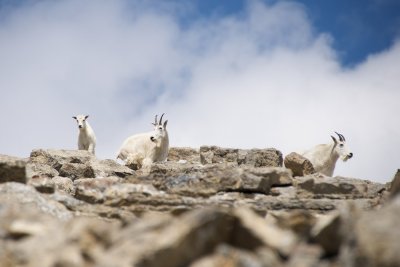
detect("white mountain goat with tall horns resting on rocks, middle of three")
[117,113,169,168]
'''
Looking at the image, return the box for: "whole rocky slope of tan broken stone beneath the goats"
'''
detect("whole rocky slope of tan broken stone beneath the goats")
[0,146,400,267]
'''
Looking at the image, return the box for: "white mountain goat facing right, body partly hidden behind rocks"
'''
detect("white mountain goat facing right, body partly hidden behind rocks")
[301,132,353,176]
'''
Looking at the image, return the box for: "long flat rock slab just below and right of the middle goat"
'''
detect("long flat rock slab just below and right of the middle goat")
[144,163,292,196]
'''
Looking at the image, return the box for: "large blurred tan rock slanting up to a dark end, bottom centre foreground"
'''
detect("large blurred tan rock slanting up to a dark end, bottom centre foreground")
[100,209,235,267]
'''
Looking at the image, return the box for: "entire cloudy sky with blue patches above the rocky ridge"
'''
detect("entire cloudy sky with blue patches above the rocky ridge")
[0,0,400,182]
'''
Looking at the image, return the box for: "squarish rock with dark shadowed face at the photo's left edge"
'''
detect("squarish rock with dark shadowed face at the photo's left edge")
[0,155,26,183]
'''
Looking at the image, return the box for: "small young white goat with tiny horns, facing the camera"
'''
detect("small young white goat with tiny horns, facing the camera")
[72,115,96,155]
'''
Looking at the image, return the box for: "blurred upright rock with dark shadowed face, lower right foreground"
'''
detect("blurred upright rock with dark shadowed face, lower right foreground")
[311,212,343,256]
